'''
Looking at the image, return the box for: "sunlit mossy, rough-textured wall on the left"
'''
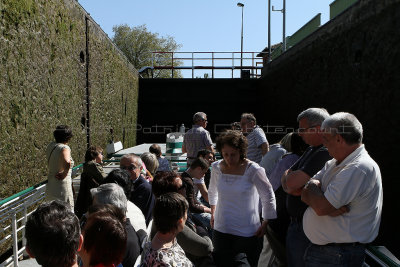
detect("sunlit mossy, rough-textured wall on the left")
[0,0,138,198]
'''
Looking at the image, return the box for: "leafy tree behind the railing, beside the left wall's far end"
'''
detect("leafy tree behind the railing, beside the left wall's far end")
[113,24,182,78]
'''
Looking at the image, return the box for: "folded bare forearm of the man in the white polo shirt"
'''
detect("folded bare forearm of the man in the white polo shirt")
[301,179,349,216]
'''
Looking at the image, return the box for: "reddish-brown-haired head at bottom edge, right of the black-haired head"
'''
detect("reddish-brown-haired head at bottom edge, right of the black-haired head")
[79,205,127,267]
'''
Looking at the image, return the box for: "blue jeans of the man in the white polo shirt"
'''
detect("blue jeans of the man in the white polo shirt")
[304,244,365,267]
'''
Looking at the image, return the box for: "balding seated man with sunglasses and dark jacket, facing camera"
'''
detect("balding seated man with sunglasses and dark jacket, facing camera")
[119,154,155,225]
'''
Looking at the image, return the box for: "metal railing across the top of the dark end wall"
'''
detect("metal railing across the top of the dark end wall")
[139,52,263,78]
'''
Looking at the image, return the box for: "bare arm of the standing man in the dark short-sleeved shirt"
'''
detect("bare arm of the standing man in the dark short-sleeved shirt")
[281,169,311,196]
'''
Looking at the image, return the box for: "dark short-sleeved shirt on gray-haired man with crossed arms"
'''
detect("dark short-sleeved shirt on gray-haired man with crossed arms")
[286,145,332,219]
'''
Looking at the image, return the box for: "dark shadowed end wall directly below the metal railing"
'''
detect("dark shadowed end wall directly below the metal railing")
[137,79,260,144]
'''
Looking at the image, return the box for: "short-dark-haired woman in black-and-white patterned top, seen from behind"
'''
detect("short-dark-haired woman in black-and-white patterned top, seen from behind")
[140,192,193,267]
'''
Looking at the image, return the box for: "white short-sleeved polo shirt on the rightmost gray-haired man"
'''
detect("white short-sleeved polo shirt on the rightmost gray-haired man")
[303,145,383,245]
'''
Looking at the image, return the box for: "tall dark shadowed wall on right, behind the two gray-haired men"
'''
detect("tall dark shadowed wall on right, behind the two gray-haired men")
[259,0,400,257]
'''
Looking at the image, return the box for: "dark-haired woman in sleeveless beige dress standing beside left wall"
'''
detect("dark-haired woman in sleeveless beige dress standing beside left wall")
[46,125,74,210]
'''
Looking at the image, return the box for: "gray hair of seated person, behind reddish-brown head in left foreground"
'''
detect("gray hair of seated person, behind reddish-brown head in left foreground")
[90,183,128,214]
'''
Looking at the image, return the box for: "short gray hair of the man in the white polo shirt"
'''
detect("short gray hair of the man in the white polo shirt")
[322,112,363,145]
